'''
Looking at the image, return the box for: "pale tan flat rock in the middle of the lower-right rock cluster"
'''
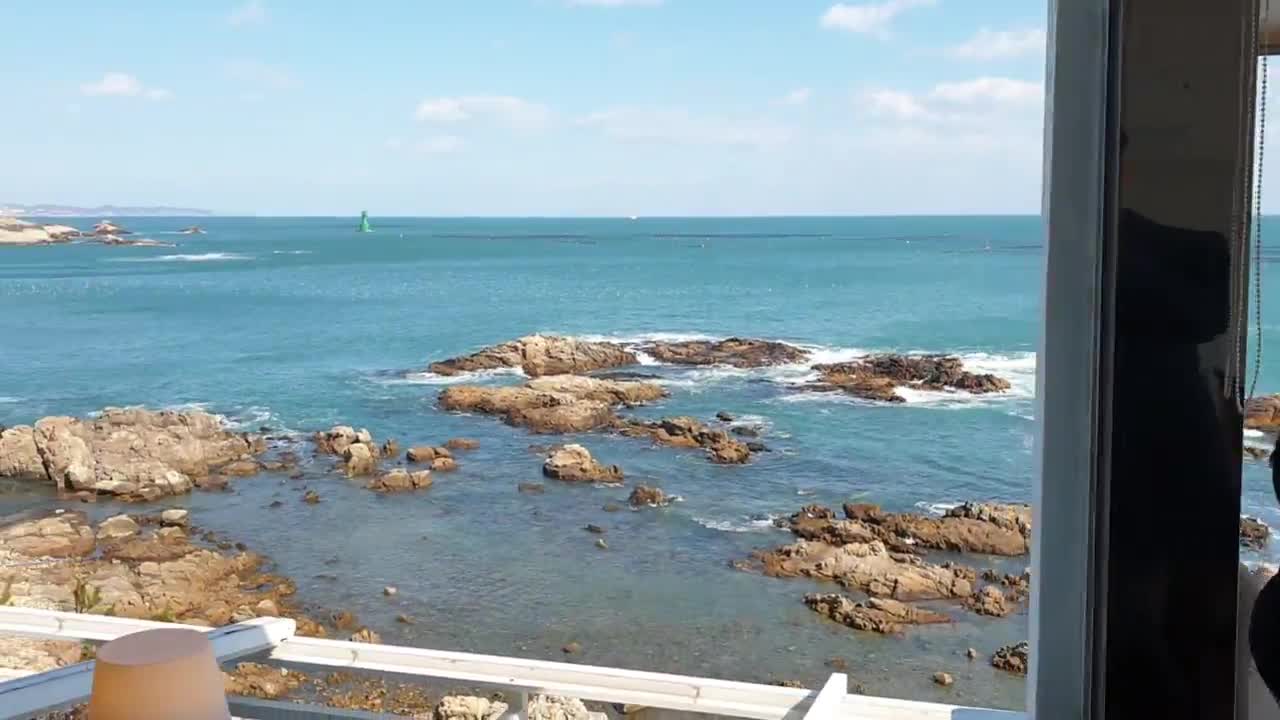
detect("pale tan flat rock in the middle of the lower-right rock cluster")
[756,541,975,601]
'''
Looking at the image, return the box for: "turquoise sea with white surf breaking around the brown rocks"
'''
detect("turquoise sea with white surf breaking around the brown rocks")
[0,217,1280,707]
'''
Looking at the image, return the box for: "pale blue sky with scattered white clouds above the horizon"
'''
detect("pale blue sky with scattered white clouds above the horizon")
[0,0,1047,215]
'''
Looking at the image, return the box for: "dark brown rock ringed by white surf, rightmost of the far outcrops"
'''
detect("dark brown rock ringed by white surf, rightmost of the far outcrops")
[809,355,1011,402]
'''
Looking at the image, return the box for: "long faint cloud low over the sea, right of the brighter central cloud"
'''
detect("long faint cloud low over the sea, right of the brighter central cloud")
[577,108,791,149]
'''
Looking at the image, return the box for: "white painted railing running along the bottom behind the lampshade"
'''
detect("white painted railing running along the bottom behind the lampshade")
[0,607,1025,720]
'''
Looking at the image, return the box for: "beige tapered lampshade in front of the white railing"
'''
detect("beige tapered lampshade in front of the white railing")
[88,628,230,720]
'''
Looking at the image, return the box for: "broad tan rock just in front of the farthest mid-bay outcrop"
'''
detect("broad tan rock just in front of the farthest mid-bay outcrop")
[439,375,667,433]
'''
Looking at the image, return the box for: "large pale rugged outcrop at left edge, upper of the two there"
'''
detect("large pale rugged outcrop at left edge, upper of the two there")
[0,407,266,500]
